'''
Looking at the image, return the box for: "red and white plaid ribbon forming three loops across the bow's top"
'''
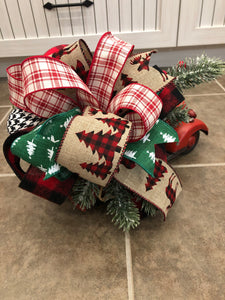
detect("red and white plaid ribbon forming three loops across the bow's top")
[7,32,162,141]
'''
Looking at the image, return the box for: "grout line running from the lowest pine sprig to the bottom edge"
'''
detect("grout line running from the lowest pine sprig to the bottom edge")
[125,231,134,300]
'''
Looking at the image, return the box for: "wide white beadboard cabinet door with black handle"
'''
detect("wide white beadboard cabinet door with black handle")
[0,0,180,57]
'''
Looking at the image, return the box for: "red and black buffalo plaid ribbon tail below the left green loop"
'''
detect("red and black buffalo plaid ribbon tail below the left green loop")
[19,166,76,204]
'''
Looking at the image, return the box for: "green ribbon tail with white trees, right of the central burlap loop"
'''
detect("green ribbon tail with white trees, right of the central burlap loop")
[124,119,179,177]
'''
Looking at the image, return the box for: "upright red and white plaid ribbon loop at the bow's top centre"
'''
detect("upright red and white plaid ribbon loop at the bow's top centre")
[87,32,133,111]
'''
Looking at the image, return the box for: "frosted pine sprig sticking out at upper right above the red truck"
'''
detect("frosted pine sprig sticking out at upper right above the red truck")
[167,54,225,92]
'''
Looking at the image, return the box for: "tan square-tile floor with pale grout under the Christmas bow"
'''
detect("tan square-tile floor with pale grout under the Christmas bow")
[0,76,225,300]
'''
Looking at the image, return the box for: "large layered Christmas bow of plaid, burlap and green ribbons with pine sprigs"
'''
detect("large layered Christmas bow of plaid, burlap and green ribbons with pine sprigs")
[4,32,223,230]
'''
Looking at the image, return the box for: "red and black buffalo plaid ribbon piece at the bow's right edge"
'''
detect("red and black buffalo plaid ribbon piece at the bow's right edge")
[159,83,184,119]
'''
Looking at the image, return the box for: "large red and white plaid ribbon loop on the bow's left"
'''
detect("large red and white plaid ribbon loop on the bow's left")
[7,56,98,118]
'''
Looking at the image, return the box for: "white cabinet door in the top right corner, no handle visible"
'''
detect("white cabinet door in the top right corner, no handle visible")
[178,0,225,46]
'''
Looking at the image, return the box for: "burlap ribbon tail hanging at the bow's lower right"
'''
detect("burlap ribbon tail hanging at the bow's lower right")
[115,159,182,218]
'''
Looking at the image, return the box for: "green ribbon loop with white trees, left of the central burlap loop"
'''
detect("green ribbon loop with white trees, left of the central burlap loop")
[11,108,81,180]
